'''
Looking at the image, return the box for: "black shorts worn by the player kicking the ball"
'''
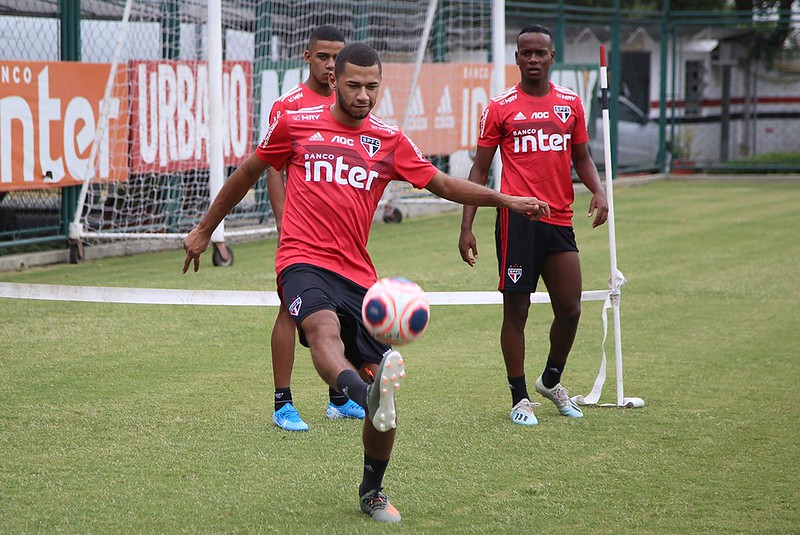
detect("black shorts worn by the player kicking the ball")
[278,264,390,368]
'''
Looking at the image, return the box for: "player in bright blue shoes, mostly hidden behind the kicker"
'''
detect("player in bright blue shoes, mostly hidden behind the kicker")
[267,26,364,431]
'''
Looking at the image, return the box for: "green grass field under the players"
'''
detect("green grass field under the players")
[0,182,800,534]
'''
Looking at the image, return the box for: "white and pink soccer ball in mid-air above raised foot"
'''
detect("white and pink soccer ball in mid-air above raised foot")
[361,277,431,345]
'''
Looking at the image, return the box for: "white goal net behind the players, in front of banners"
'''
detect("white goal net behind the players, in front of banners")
[70,0,491,247]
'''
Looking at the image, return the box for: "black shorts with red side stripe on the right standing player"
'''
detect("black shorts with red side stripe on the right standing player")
[494,208,578,292]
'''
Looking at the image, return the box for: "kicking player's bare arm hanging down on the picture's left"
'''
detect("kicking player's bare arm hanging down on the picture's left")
[183,154,268,273]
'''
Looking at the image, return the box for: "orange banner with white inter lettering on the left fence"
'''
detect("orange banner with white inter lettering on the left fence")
[0,61,128,191]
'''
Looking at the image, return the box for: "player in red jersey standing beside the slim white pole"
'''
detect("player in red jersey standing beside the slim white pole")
[458,25,608,425]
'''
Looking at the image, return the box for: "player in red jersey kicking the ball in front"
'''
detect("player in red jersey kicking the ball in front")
[183,43,550,522]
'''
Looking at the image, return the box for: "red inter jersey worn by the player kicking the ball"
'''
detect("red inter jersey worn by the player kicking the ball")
[255,106,437,288]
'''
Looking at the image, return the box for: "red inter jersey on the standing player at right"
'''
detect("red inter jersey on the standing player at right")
[478,82,589,226]
